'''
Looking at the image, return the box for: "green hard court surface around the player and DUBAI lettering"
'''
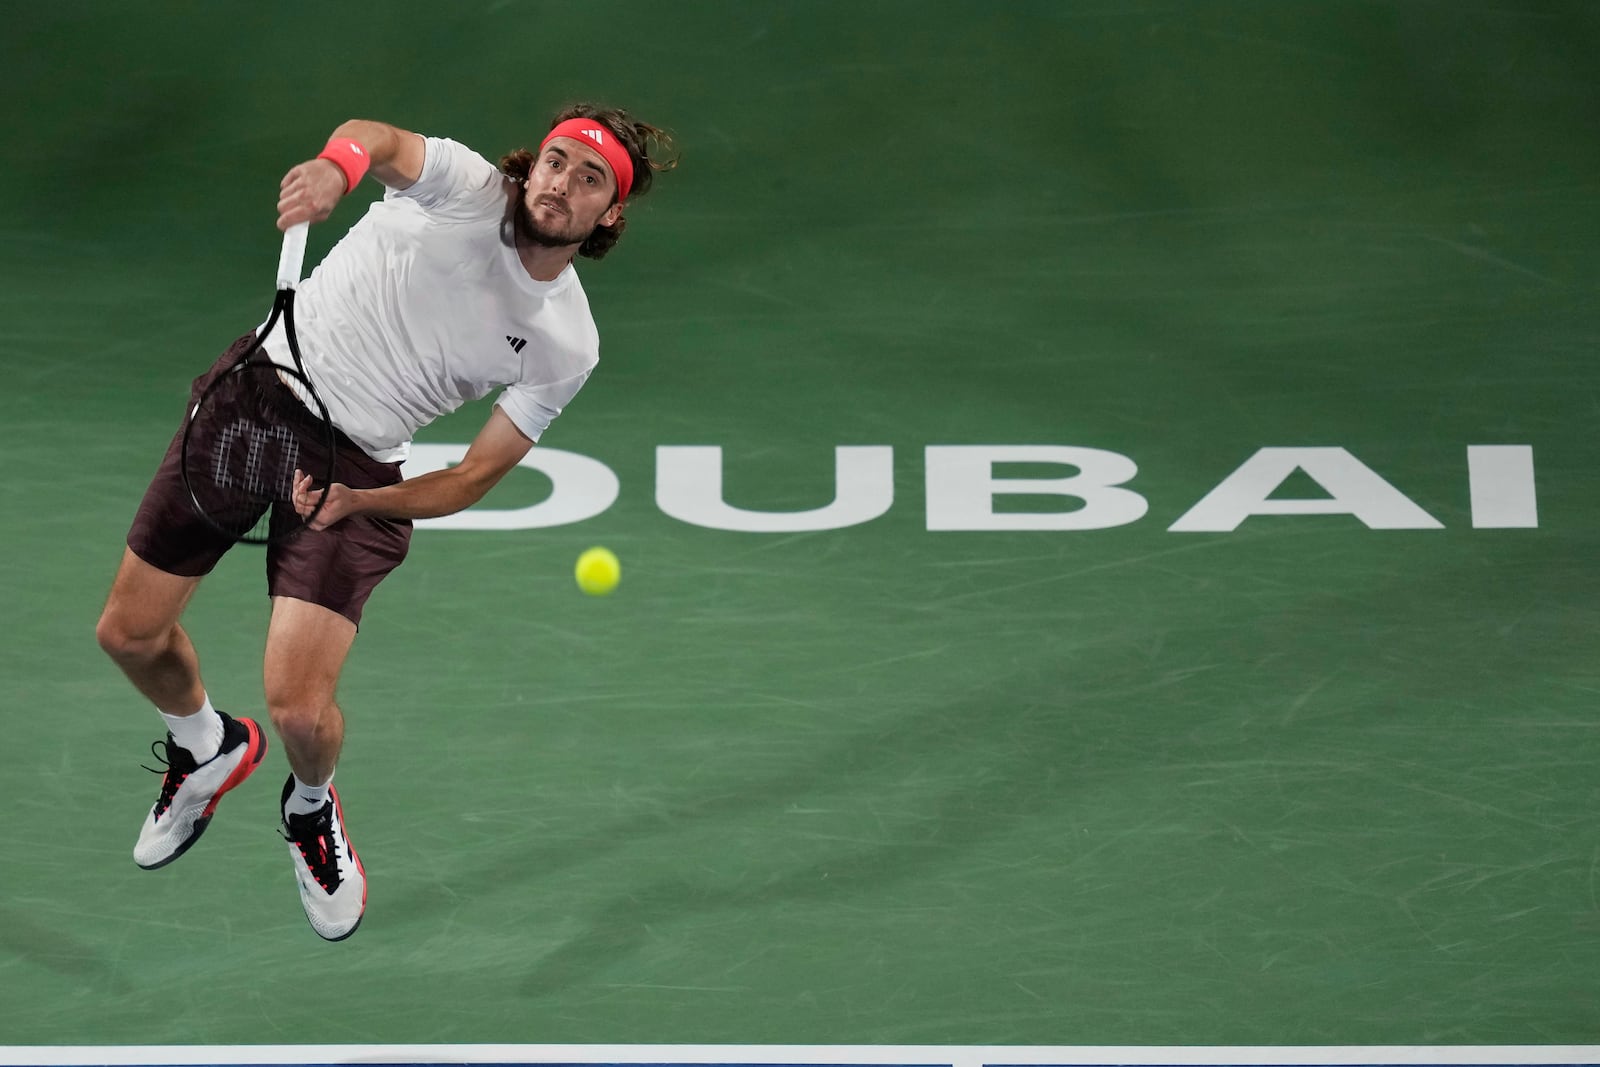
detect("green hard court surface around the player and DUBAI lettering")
[0,0,1600,1046]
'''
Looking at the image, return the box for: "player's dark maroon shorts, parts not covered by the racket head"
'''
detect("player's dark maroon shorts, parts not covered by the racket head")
[128,334,411,625]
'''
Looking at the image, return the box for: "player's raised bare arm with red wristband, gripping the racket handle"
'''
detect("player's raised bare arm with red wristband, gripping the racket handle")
[278,118,424,230]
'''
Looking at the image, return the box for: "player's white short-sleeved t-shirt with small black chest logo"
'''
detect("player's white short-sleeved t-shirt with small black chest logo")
[266,138,600,462]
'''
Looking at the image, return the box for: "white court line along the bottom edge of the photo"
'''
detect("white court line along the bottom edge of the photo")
[0,1045,1600,1067]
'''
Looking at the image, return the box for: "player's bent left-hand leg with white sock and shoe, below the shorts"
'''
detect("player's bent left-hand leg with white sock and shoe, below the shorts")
[94,550,267,870]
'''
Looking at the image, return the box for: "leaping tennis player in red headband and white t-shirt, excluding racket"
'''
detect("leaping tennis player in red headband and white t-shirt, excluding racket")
[96,104,675,941]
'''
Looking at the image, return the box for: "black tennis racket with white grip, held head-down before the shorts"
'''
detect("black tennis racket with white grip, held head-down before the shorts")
[182,222,336,544]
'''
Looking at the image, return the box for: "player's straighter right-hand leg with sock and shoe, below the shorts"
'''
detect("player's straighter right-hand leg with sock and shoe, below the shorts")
[264,597,366,941]
